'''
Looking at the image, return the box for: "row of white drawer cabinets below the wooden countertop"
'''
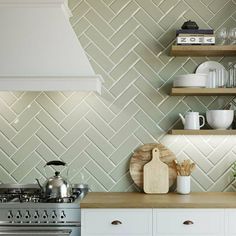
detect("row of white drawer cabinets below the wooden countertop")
[81,208,236,236]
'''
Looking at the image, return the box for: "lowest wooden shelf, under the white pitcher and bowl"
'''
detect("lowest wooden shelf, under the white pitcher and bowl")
[168,129,236,135]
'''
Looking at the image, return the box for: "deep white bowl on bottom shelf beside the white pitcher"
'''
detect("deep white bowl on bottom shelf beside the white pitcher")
[206,110,234,129]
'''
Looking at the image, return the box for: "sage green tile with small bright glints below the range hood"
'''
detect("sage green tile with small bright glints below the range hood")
[11,101,41,131]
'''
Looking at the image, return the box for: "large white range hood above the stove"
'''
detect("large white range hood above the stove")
[0,0,102,93]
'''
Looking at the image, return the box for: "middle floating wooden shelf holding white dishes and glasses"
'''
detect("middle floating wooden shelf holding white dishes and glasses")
[171,88,236,96]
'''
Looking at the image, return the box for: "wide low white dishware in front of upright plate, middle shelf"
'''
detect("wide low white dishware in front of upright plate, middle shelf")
[173,74,207,87]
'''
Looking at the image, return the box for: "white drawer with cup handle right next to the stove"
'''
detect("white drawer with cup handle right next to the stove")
[81,209,152,236]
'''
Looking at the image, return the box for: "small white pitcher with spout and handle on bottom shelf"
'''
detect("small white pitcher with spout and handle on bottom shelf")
[179,112,205,130]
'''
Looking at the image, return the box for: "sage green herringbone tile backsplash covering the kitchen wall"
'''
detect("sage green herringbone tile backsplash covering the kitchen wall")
[0,0,236,191]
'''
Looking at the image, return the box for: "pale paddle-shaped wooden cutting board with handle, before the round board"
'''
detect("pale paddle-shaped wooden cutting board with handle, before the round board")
[143,148,169,194]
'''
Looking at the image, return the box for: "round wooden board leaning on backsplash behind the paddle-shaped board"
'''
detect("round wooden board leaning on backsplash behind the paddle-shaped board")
[129,143,177,190]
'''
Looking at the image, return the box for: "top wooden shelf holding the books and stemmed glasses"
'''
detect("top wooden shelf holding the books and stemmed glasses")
[171,45,236,57]
